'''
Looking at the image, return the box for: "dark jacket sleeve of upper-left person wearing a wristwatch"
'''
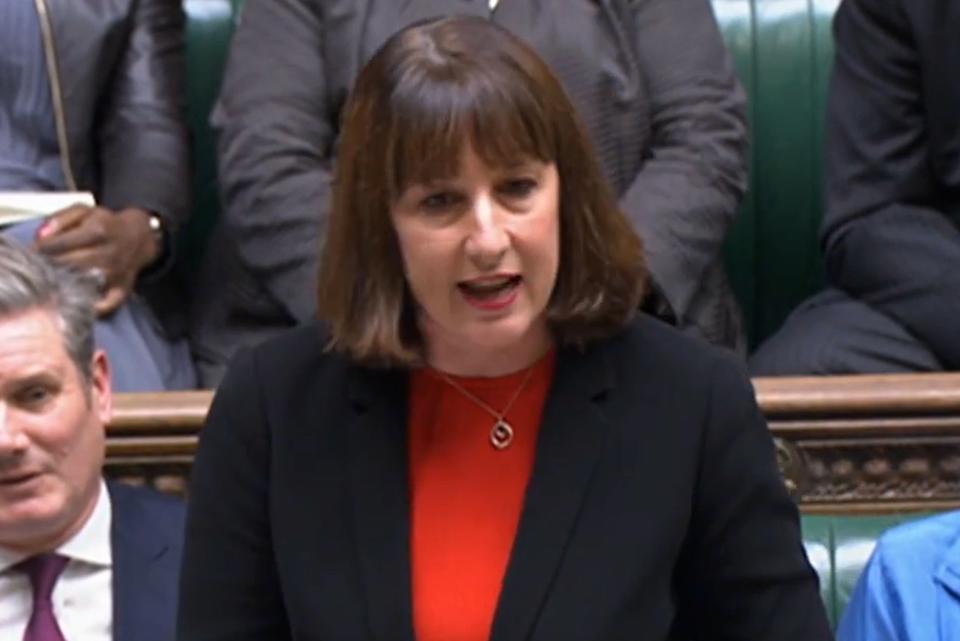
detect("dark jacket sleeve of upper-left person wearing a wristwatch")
[97,0,190,227]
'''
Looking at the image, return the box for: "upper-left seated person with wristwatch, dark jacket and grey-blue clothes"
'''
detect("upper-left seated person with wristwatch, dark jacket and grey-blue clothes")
[0,0,196,391]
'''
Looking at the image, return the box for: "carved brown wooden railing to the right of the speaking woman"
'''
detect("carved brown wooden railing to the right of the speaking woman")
[754,374,960,513]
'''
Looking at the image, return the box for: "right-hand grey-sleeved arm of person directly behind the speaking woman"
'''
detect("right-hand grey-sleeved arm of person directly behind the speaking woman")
[620,0,748,326]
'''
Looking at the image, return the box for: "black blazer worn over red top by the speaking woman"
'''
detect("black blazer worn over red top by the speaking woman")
[178,319,832,641]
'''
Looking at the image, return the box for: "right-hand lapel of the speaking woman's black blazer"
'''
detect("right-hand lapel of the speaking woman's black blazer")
[490,340,614,641]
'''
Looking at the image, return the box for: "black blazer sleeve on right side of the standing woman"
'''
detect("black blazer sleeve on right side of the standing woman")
[681,357,833,641]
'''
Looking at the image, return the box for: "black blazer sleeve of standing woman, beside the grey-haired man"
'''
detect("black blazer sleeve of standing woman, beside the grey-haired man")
[177,352,290,641]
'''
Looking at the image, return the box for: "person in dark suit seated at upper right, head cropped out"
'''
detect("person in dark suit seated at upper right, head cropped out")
[751,0,960,375]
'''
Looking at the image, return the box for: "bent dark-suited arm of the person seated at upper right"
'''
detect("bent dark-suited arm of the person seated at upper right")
[823,0,960,368]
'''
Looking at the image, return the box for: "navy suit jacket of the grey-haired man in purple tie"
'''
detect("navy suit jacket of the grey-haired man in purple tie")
[110,488,177,641]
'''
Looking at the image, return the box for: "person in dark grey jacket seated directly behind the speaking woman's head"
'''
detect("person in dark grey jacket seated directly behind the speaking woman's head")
[190,0,748,387]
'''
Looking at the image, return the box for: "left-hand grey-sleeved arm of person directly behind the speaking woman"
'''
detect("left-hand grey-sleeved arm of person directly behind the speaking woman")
[214,0,336,322]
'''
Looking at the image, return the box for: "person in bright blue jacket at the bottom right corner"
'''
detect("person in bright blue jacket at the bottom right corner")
[837,512,960,641]
